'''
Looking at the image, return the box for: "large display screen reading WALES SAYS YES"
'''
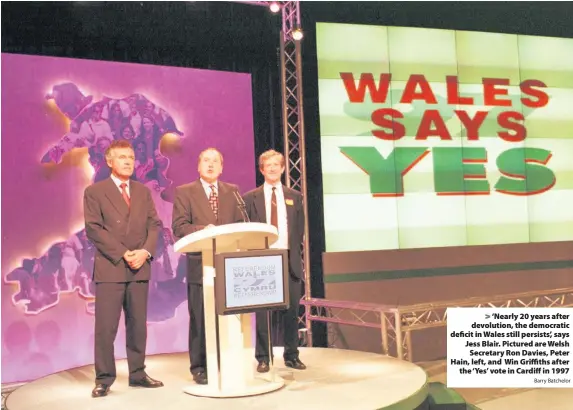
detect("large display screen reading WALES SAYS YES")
[317,23,573,252]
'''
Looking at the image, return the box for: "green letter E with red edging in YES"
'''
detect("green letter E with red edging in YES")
[432,147,490,195]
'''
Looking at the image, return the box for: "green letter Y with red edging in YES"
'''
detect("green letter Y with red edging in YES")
[340,147,429,196]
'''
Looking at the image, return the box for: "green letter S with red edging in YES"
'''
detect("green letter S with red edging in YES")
[495,147,556,195]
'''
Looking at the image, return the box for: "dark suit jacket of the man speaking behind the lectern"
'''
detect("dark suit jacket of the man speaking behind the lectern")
[171,180,243,284]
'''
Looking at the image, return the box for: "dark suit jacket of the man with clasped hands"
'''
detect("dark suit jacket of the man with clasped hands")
[84,178,161,282]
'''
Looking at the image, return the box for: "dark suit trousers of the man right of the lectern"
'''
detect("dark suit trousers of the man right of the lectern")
[255,275,302,362]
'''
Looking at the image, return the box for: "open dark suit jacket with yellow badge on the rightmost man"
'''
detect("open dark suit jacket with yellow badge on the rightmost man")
[243,185,304,279]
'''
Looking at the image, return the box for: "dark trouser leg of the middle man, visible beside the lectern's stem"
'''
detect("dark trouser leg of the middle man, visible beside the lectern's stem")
[187,283,207,374]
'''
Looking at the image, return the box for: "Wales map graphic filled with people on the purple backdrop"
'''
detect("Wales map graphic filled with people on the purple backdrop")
[5,82,187,322]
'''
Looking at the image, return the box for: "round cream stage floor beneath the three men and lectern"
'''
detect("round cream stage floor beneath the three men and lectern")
[6,348,427,410]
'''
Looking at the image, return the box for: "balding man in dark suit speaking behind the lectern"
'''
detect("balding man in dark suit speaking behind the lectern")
[172,148,243,384]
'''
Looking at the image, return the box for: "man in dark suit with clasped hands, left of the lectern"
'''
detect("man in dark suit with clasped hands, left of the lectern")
[84,140,163,397]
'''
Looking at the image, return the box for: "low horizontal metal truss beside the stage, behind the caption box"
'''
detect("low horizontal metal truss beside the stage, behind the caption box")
[303,288,573,361]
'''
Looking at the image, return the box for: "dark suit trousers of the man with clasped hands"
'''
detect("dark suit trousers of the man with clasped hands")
[94,281,149,385]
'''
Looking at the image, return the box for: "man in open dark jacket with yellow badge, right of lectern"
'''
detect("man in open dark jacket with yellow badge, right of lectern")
[243,150,306,373]
